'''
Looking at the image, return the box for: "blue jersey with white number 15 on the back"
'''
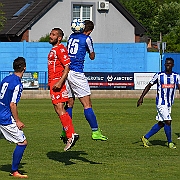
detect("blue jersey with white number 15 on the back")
[67,33,94,72]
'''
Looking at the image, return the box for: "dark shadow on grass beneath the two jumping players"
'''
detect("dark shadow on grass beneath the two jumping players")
[47,151,102,165]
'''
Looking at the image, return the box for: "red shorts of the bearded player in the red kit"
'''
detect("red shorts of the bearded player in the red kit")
[49,80,68,104]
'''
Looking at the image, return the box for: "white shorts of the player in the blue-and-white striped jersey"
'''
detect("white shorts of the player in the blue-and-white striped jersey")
[156,105,172,121]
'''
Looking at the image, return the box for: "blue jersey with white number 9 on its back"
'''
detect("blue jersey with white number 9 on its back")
[0,74,23,125]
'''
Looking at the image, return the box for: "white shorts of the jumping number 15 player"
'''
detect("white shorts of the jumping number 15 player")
[67,70,91,98]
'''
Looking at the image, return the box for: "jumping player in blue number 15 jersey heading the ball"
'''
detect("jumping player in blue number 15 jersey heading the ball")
[67,20,108,141]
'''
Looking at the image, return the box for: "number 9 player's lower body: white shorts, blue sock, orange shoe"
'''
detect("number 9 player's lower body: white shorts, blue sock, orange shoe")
[0,121,28,178]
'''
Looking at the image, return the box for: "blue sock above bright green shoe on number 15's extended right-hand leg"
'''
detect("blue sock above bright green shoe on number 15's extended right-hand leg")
[84,108,98,131]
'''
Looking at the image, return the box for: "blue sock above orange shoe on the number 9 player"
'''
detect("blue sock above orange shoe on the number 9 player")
[12,145,27,172]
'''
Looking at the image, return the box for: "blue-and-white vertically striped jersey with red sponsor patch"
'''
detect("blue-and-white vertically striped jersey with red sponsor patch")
[150,72,180,107]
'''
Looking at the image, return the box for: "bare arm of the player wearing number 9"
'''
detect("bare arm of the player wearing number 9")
[10,102,25,129]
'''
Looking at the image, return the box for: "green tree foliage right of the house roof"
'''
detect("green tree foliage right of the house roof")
[119,0,180,52]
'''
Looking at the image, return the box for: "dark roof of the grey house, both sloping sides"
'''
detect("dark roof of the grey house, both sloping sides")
[0,0,146,36]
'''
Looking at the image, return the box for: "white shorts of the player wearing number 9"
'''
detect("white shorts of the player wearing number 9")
[0,117,26,144]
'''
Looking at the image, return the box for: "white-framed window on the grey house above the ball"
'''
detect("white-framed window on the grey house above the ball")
[72,3,95,22]
